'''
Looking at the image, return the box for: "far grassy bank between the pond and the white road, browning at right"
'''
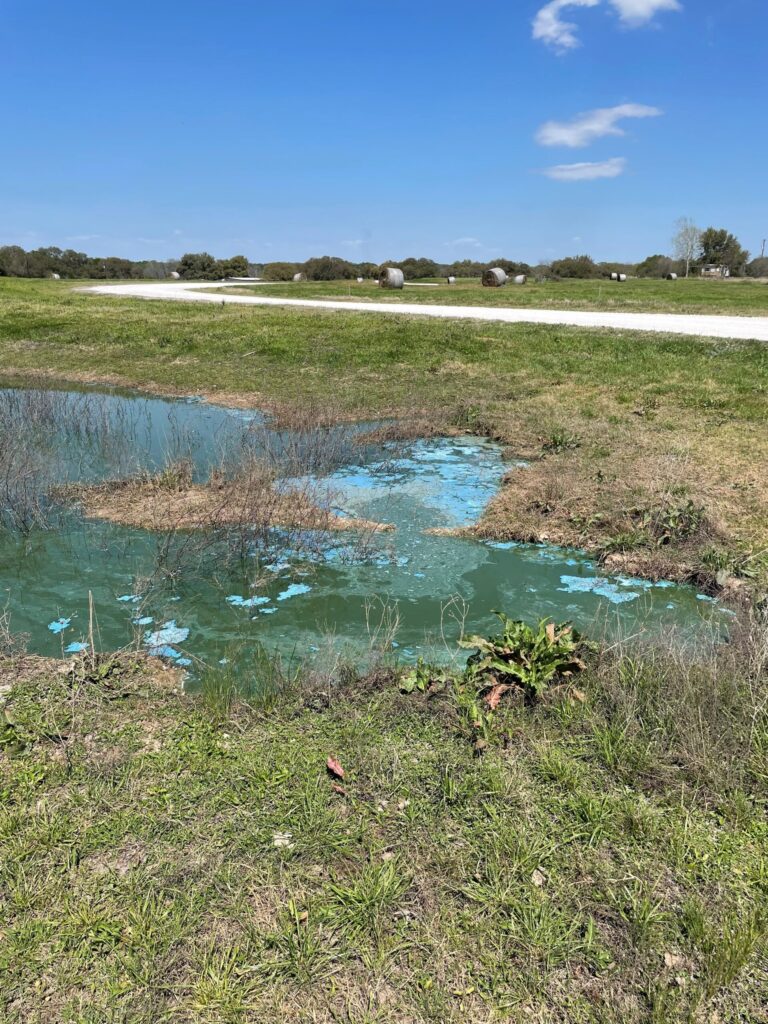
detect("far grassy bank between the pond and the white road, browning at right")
[0,281,768,586]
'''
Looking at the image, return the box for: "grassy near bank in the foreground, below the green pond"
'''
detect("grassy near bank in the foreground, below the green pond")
[0,626,768,1024]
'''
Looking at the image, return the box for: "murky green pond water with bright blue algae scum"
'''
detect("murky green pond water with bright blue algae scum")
[0,387,724,672]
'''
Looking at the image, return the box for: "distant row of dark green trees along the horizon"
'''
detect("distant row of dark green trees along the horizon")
[0,218,768,282]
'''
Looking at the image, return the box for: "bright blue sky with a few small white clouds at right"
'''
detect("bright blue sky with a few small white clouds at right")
[0,0,768,262]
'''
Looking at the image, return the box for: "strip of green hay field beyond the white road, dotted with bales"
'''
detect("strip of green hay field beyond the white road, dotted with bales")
[228,278,768,316]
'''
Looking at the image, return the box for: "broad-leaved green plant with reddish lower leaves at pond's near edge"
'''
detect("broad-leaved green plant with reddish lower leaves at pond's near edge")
[461,611,590,707]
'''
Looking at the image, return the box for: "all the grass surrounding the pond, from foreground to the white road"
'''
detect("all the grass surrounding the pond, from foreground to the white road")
[0,281,768,1024]
